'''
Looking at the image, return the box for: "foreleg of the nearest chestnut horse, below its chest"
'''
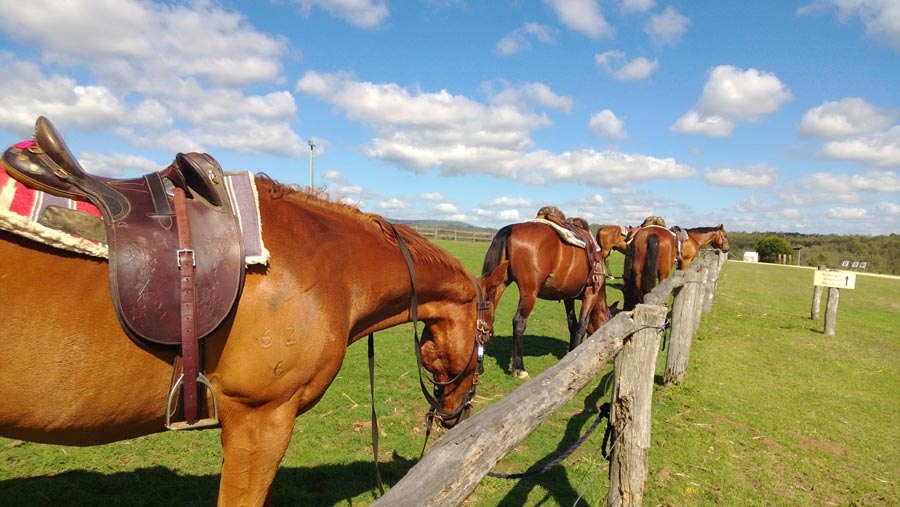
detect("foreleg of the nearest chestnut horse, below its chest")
[218,400,297,506]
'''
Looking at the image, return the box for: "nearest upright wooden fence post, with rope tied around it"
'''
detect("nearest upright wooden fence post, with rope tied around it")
[604,304,668,507]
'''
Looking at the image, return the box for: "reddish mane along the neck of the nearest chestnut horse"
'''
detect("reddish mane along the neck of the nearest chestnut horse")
[250,173,471,277]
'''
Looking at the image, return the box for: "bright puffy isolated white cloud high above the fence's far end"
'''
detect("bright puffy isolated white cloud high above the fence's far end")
[671,65,792,137]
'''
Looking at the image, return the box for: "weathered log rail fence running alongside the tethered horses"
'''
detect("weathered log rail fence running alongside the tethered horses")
[372,252,727,507]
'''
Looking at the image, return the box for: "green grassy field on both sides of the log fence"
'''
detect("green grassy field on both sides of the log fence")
[0,241,900,507]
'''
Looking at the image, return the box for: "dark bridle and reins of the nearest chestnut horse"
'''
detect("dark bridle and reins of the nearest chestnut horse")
[368,222,491,495]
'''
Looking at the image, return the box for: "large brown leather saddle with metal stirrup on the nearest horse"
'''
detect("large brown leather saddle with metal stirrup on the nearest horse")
[0,116,244,429]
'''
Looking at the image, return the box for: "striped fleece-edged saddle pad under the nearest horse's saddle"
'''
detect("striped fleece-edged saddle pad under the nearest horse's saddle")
[0,167,269,265]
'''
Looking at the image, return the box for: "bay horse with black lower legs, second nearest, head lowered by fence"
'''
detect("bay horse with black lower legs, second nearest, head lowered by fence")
[481,222,609,378]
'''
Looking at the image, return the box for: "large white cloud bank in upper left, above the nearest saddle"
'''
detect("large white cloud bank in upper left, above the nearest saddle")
[0,0,303,157]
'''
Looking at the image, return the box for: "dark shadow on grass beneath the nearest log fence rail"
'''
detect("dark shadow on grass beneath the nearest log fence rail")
[488,372,614,507]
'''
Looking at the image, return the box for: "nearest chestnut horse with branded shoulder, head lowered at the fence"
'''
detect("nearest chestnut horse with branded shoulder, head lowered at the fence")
[0,176,506,506]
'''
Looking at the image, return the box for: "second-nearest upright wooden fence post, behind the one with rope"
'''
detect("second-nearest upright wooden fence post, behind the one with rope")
[663,269,700,385]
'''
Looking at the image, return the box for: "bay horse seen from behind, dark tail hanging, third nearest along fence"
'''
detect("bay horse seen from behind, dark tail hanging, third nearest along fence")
[622,225,677,311]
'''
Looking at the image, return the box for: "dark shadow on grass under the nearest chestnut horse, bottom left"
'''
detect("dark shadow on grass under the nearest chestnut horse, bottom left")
[0,456,416,507]
